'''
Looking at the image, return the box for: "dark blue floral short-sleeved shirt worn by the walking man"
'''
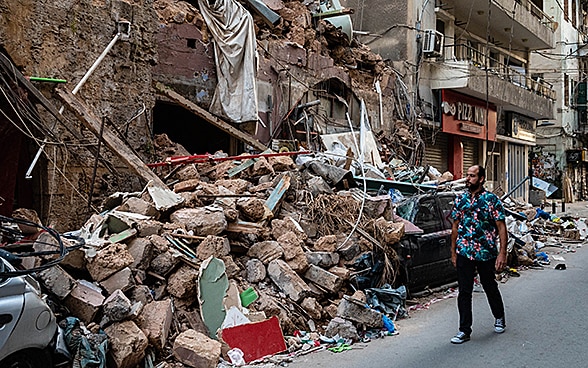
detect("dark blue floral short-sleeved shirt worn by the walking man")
[451,190,505,261]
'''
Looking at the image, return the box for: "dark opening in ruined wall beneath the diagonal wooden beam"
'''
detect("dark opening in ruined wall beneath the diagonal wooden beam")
[153,101,234,154]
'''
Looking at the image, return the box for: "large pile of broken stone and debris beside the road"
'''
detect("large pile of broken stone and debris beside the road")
[24,137,406,367]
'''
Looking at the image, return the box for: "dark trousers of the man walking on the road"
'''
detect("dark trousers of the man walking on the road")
[456,254,504,336]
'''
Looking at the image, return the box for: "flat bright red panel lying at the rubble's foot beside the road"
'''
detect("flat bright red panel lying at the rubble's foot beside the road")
[222,316,286,363]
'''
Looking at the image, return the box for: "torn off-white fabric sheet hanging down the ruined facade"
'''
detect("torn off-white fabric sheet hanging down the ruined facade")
[198,0,258,123]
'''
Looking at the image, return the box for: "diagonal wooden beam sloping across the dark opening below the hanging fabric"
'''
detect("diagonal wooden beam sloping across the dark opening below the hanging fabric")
[155,82,267,151]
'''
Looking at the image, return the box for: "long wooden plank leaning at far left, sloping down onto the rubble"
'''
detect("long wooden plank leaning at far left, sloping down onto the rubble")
[57,89,167,188]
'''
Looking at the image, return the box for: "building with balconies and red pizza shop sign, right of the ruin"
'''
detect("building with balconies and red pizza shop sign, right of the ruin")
[347,0,559,200]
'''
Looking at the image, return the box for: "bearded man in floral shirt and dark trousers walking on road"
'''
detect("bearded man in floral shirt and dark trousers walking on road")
[451,165,507,344]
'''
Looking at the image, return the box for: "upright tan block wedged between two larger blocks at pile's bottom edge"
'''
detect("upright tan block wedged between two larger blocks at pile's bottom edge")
[138,299,172,351]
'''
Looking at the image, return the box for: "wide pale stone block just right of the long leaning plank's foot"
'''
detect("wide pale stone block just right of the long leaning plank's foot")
[170,206,227,236]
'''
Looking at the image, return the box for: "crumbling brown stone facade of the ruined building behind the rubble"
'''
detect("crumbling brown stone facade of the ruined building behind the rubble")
[0,1,398,228]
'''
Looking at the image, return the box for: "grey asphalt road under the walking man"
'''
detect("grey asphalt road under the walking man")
[289,243,588,368]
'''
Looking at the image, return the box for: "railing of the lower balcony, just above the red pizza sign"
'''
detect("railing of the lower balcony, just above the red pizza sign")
[446,44,556,100]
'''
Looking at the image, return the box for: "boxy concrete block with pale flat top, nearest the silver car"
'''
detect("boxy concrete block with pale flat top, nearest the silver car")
[64,280,104,323]
